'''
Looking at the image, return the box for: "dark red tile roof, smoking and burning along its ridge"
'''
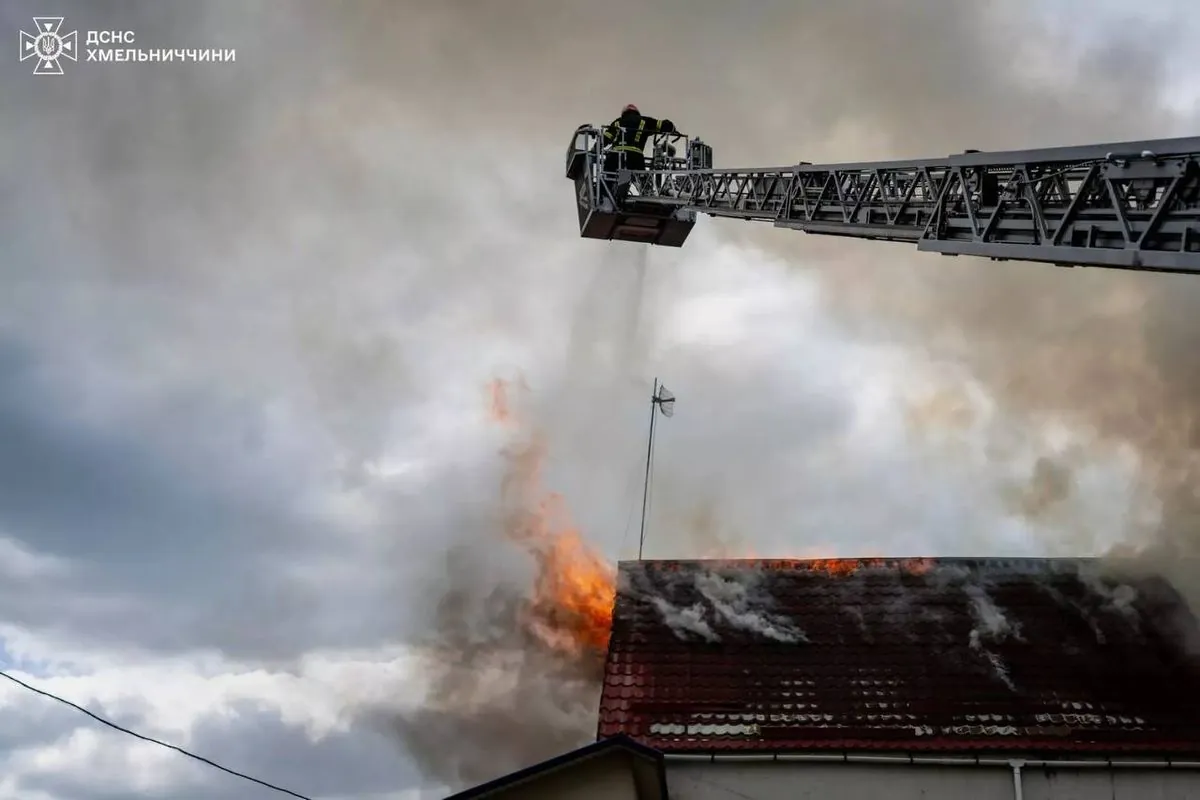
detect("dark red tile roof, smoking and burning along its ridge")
[599,559,1200,754]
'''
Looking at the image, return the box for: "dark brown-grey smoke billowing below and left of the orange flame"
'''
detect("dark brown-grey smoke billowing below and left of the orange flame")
[384,542,602,788]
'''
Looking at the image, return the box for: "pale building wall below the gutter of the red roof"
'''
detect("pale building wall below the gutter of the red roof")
[667,760,1200,800]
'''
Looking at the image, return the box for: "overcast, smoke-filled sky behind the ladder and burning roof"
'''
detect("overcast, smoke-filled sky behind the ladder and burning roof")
[0,0,1200,800]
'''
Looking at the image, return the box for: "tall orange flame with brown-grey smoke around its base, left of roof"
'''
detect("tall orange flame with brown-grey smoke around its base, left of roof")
[376,379,616,787]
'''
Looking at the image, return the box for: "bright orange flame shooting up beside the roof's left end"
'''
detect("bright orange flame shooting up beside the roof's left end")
[488,379,617,656]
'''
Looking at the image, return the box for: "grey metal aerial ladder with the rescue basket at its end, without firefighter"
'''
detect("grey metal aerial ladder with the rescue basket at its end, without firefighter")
[566,125,1200,273]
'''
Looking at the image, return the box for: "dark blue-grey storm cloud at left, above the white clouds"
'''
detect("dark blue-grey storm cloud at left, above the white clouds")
[0,331,417,655]
